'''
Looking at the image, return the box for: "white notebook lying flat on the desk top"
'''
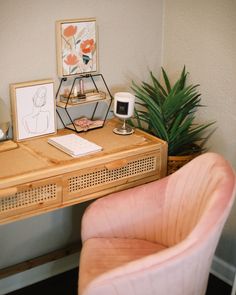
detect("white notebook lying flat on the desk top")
[48,134,102,157]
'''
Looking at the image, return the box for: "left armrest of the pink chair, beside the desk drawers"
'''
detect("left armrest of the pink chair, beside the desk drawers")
[82,178,168,241]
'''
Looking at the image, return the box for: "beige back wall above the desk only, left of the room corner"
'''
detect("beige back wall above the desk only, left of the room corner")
[0,0,162,106]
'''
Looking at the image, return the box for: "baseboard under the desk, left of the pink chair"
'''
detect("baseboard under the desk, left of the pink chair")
[0,253,79,295]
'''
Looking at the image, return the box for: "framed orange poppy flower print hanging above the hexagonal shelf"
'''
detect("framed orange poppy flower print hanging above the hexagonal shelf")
[56,18,98,77]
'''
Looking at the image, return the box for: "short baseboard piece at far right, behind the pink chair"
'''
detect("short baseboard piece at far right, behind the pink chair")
[211,256,236,286]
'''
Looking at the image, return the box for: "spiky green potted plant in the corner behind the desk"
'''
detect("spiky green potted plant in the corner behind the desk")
[130,66,214,174]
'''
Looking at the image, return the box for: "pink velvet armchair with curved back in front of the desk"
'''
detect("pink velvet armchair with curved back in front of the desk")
[79,153,235,295]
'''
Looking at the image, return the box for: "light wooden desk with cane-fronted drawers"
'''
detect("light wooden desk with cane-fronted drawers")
[0,120,167,224]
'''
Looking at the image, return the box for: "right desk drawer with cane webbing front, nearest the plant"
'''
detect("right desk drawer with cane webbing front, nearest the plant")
[63,152,160,201]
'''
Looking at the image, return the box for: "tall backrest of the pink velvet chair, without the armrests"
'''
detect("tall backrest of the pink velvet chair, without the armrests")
[161,153,235,246]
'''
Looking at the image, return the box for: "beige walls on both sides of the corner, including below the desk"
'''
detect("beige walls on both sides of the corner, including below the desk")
[0,0,236,294]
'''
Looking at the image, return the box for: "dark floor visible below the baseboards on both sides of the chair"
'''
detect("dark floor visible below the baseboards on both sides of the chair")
[7,269,231,295]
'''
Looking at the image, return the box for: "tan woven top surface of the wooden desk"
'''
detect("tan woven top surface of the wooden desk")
[0,121,165,189]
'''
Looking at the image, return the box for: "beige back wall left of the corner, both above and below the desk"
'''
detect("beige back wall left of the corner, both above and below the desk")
[0,0,163,293]
